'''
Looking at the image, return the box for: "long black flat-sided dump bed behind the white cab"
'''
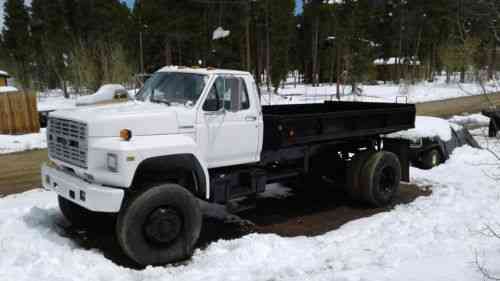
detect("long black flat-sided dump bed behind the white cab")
[262,102,415,150]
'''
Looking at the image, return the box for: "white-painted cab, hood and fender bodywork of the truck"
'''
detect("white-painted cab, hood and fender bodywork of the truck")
[42,67,263,212]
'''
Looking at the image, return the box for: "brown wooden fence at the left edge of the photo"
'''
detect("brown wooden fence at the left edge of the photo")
[0,89,40,135]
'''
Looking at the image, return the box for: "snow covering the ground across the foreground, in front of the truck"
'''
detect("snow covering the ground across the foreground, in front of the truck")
[0,127,500,281]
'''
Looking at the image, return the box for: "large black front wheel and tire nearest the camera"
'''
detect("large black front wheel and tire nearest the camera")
[116,184,202,266]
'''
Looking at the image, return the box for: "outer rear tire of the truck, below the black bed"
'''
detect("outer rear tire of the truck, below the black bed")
[360,151,401,207]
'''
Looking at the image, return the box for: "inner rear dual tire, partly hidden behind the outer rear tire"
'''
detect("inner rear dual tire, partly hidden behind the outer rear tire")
[345,151,375,201]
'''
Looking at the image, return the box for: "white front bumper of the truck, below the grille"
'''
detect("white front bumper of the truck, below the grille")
[42,163,125,213]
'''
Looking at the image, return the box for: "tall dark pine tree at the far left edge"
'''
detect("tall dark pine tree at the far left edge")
[2,0,33,89]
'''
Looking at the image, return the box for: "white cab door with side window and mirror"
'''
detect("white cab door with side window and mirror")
[202,76,260,167]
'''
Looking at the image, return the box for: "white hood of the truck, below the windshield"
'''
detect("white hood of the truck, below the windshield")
[50,101,195,137]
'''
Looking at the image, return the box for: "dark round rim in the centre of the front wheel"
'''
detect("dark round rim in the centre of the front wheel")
[143,207,182,244]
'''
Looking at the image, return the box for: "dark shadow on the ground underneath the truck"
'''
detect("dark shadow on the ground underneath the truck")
[63,185,431,269]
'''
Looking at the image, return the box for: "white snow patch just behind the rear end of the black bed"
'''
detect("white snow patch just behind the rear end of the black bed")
[387,116,451,141]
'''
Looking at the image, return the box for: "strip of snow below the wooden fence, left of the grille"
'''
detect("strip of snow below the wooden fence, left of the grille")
[0,129,47,154]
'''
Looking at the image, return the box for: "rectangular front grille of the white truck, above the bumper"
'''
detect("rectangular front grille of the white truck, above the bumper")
[47,118,87,169]
